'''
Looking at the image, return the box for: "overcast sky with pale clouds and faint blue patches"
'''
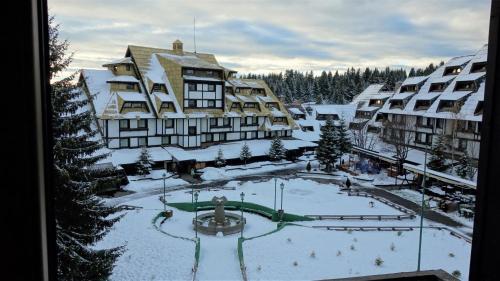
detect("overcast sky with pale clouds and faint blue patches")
[49,0,490,73]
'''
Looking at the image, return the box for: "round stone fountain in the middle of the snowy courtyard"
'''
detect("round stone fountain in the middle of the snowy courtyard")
[193,196,246,235]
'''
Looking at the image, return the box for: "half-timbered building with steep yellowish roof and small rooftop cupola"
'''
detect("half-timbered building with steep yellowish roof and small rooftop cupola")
[79,40,297,149]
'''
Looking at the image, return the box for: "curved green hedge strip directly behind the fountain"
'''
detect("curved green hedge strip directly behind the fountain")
[167,201,314,222]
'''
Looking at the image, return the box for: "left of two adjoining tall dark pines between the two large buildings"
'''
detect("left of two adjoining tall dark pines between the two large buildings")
[316,118,339,172]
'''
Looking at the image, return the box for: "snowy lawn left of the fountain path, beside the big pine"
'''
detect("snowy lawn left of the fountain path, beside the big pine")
[96,196,195,281]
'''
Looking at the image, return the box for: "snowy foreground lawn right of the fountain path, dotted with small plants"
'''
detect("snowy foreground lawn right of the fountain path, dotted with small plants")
[243,223,470,280]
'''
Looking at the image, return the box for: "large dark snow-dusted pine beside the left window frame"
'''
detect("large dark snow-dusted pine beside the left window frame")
[49,17,123,280]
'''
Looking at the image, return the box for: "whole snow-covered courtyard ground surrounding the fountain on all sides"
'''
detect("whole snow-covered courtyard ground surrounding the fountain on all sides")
[100,178,470,280]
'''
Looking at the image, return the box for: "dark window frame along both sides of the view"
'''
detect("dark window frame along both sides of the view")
[13,0,500,281]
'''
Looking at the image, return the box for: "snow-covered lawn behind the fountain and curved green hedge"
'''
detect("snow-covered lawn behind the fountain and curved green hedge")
[167,178,402,215]
